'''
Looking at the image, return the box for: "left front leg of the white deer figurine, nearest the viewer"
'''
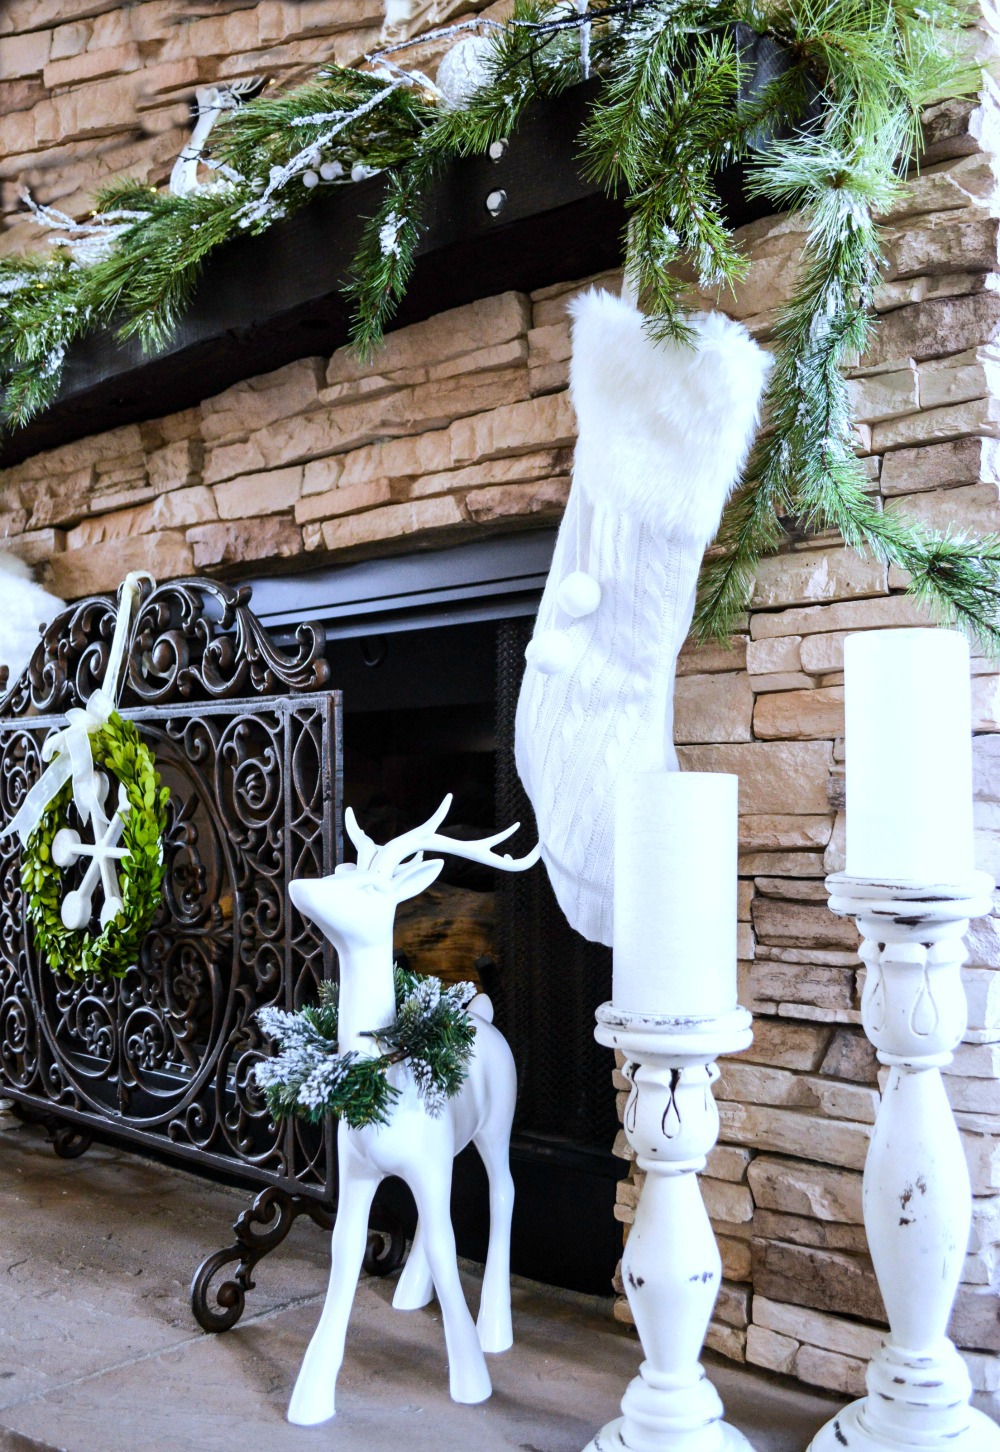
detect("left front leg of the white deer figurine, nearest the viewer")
[289,1143,382,1427]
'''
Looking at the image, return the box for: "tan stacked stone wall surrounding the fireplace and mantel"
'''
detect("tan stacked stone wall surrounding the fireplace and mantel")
[0,0,1000,1410]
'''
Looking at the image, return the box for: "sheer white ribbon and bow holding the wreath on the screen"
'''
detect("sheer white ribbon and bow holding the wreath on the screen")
[0,571,157,847]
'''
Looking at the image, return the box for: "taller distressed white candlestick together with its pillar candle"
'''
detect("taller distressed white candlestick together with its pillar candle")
[810,630,1000,1452]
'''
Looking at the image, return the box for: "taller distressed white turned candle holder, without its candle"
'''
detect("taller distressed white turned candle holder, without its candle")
[810,873,1000,1452]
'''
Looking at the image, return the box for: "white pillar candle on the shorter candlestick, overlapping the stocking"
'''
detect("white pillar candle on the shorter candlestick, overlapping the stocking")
[611,771,739,1018]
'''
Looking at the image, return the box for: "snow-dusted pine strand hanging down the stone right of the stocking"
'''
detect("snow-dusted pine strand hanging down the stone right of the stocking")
[695,0,1000,644]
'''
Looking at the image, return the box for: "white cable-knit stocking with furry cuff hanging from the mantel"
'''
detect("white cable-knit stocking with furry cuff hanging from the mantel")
[515,292,769,944]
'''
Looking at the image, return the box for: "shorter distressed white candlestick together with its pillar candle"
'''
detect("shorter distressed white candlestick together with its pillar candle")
[588,771,752,1452]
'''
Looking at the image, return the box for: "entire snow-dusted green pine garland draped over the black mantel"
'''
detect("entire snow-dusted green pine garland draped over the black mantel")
[0,0,1000,655]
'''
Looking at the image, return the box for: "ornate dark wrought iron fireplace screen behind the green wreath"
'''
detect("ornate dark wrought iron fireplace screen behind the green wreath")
[0,579,341,1201]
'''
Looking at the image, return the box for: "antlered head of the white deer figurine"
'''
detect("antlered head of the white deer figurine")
[289,793,541,953]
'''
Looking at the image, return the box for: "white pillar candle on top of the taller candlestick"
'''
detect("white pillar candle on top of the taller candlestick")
[843,630,974,883]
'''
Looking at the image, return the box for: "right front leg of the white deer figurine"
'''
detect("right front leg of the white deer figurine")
[409,1159,493,1403]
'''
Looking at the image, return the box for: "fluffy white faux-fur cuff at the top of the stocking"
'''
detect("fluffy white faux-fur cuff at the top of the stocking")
[570,290,771,547]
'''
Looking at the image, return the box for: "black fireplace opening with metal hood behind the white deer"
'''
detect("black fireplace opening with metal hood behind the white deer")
[254,536,624,1294]
